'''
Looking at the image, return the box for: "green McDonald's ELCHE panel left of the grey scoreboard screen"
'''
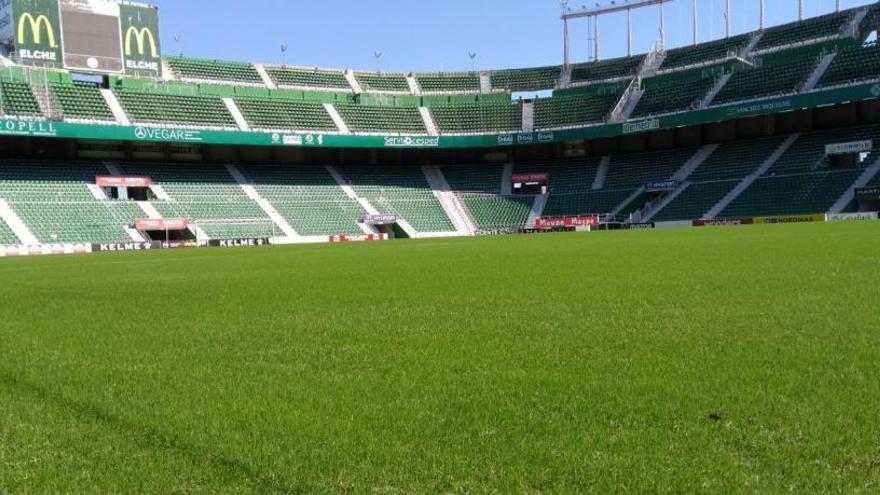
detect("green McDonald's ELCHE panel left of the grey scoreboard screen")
[12,0,63,67]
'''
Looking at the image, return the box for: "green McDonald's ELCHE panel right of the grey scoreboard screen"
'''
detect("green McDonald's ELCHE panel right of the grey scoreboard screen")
[119,4,162,78]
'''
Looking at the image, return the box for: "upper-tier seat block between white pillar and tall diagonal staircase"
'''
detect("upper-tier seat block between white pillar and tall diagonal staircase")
[535,88,623,129]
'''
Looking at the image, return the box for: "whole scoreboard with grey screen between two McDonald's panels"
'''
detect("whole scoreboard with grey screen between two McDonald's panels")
[0,0,162,78]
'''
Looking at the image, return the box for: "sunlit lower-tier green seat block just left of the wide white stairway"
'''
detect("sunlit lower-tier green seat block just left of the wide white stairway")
[338,166,455,232]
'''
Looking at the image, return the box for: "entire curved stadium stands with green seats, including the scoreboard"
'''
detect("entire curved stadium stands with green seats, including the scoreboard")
[0,0,880,254]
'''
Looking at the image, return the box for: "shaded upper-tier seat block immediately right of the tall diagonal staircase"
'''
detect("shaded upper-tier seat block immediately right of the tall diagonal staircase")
[632,69,717,117]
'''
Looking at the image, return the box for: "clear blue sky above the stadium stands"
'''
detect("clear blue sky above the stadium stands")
[151,0,873,71]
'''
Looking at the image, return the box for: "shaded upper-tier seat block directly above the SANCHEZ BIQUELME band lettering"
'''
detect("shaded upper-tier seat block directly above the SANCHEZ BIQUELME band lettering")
[712,52,820,105]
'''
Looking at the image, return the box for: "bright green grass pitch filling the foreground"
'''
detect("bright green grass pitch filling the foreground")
[0,222,880,493]
